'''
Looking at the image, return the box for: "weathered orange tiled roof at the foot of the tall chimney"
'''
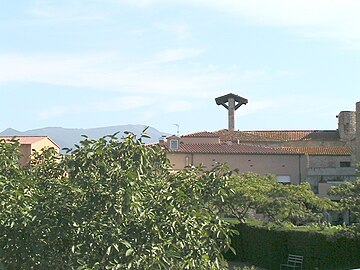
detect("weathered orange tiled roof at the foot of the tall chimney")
[215,129,339,141]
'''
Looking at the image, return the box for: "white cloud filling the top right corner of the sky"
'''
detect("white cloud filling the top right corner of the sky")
[191,0,360,48]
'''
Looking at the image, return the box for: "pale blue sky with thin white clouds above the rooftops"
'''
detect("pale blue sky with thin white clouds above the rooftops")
[0,0,360,134]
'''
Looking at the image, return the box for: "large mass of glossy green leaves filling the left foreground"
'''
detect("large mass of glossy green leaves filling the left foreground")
[0,134,231,270]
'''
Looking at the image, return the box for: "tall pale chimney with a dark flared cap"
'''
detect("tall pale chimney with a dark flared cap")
[215,93,248,131]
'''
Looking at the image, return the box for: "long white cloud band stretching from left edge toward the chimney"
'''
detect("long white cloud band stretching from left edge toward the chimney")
[0,50,233,98]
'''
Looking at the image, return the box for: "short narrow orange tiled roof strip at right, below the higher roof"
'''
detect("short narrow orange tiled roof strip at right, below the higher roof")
[279,146,352,156]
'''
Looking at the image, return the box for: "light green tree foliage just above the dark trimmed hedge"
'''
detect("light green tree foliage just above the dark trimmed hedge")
[218,173,336,225]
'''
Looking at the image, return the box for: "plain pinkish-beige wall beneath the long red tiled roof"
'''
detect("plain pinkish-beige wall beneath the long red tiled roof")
[167,153,305,184]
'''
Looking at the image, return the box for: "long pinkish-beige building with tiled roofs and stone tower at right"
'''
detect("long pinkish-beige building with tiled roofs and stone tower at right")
[162,99,360,197]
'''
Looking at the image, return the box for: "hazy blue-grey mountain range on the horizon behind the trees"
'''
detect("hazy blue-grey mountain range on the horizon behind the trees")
[0,125,169,151]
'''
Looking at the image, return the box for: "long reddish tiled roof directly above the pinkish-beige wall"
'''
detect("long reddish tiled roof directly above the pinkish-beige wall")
[168,144,298,155]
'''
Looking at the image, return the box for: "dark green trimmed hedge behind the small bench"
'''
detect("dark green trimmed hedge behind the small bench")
[229,224,360,270]
